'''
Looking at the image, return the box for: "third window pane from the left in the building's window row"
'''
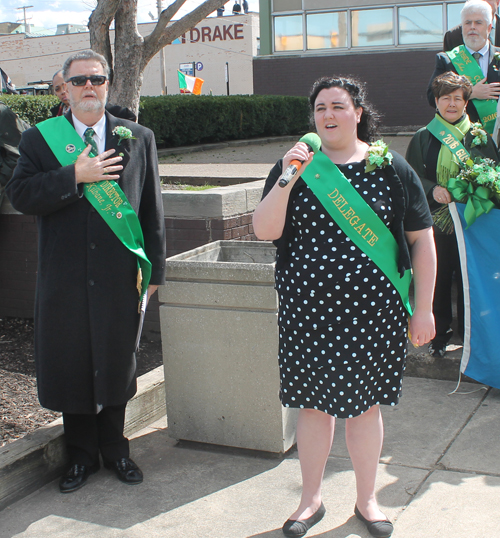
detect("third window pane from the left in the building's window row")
[351,8,394,47]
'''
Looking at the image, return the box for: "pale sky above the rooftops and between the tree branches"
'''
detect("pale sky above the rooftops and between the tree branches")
[0,0,259,29]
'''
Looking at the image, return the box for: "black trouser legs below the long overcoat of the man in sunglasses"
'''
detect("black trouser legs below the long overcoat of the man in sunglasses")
[63,404,129,465]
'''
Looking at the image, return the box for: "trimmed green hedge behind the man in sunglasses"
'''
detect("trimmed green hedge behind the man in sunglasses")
[0,94,309,147]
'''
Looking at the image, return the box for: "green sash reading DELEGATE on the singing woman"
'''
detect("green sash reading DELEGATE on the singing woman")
[301,151,412,316]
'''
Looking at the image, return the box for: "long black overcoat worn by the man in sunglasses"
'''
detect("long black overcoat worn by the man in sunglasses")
[7,112,165,414]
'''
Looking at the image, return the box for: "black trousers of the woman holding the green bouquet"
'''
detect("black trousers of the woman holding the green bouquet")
[432,233,464,344]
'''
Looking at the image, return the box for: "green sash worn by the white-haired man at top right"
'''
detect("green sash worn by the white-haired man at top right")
[446,45,498,135]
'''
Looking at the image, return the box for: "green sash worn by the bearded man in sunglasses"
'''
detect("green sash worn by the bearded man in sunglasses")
[36,116,151,299]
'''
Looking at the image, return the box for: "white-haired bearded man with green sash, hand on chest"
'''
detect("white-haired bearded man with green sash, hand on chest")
[427,0,500,134]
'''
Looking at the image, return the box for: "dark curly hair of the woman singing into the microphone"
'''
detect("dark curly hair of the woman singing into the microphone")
[309,76,380,144]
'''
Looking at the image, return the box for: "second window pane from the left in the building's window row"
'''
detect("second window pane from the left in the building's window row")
[306,11,347,49]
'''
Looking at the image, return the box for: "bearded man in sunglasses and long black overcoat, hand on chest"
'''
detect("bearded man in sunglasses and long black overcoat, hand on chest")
[6,51,165,493]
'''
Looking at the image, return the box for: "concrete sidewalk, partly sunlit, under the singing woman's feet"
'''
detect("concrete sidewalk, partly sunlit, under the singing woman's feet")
[0,378,500,538]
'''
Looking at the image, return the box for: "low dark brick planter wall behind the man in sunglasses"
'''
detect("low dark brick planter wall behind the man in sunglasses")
[0,213,256,340]
